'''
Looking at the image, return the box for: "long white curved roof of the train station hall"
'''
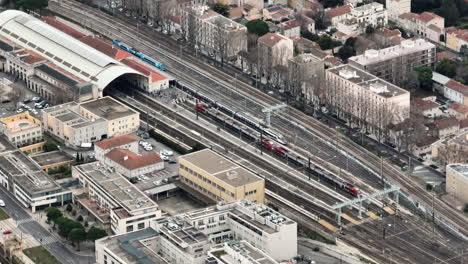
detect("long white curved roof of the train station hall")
[0,10,141,90]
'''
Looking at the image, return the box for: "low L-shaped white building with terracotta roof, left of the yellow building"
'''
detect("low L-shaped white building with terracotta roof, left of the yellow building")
[103,148,164,178]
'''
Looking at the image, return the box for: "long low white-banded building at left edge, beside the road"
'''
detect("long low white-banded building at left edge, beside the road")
[0,135,72,213]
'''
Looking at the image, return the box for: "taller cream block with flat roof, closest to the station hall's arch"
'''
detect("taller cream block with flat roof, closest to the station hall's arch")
[79,96,140,137]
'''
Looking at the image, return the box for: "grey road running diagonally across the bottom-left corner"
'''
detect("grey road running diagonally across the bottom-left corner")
[0,187,94,264]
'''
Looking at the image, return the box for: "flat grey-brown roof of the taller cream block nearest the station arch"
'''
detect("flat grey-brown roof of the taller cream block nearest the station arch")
[80,96,137,120]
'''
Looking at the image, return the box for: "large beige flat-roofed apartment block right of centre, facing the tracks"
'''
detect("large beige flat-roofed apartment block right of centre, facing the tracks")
[325,64,410,129]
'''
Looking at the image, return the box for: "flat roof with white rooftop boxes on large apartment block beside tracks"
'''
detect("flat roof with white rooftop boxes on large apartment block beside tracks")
[327,64,409,98]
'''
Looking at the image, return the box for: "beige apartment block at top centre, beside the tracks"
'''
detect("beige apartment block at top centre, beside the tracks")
[180,5,247,59]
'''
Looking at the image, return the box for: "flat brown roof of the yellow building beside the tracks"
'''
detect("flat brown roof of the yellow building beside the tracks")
[179,149,263,187]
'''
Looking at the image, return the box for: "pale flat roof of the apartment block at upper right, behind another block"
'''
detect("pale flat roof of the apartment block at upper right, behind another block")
[348,39,436,65]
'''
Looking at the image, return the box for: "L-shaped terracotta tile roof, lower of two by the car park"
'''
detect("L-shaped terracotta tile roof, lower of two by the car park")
[105,148,163,170]
